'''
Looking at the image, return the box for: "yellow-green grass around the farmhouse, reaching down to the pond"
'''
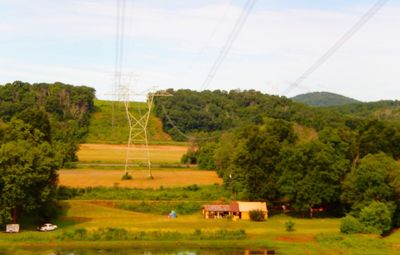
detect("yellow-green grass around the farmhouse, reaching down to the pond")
[0,200,400,255]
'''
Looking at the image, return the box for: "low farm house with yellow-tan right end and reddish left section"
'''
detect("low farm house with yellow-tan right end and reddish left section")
[202,202,268,220]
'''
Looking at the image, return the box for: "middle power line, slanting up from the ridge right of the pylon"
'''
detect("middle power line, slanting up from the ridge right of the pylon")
[200,0,256,90]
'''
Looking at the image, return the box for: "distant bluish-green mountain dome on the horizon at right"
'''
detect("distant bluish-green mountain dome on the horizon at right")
[291,92,360,107]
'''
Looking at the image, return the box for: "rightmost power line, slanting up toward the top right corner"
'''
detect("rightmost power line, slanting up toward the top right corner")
[283,0,389,95]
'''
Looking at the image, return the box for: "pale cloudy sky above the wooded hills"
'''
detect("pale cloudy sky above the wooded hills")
[0,0,400,101]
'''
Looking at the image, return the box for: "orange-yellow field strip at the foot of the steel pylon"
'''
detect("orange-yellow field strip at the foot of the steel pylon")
[58,169,222,188]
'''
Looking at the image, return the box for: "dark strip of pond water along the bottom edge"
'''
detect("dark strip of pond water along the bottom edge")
[0,248,277,255]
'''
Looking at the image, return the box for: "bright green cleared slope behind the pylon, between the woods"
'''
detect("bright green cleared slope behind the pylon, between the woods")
[86,100,172,143]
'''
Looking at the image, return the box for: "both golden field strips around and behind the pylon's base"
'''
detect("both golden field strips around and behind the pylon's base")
[58,144,222,188]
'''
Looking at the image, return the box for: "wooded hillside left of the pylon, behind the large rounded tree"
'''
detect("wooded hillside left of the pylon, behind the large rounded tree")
[0,81,95,165]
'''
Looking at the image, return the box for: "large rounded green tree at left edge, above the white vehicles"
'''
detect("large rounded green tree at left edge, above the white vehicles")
[0,120,59,224]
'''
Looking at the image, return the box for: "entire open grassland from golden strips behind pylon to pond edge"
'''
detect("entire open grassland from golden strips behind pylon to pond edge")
[4,141,400,255]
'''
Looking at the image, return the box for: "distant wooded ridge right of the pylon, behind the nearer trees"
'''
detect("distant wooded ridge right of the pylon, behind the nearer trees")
[155,89,347,140]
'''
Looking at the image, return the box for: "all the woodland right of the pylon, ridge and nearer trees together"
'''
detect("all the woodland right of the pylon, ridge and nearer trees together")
[156,90,400,234]
